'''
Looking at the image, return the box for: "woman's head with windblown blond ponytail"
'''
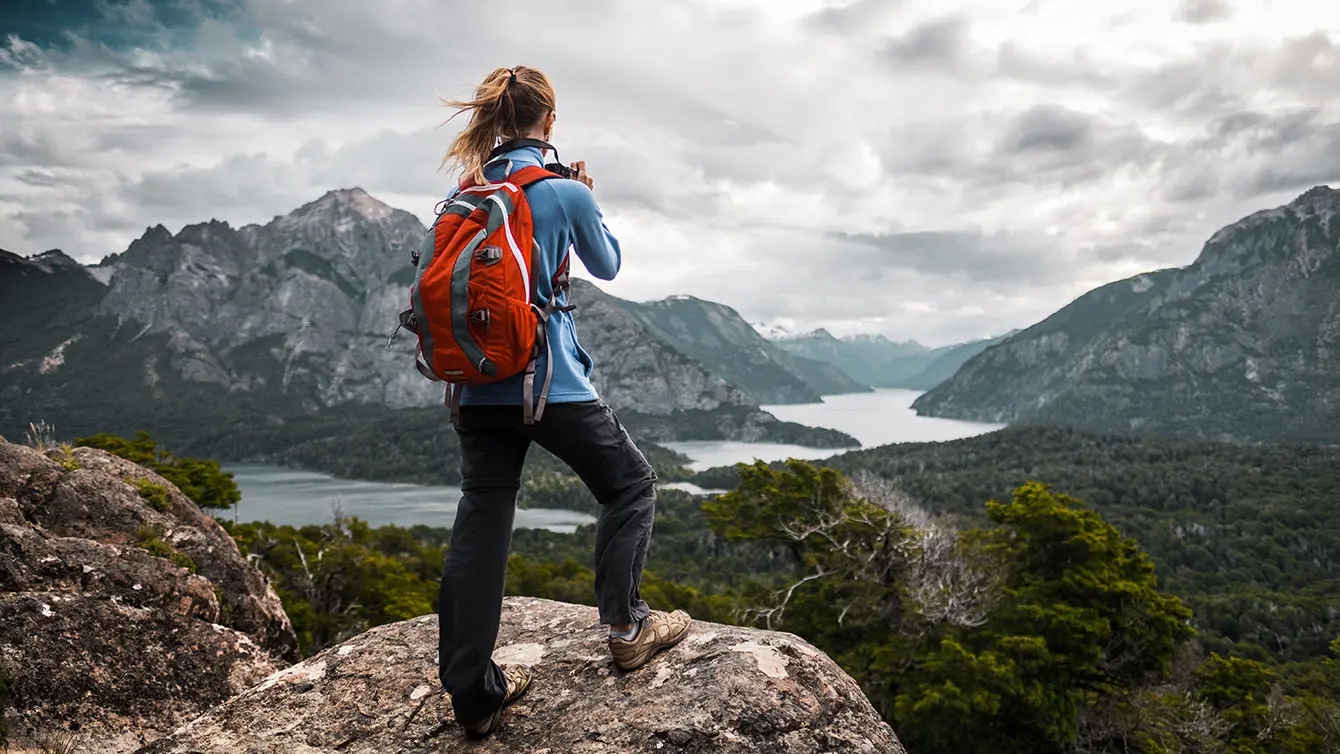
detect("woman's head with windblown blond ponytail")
[442,66,555,182]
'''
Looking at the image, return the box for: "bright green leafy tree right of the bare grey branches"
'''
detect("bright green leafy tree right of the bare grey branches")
[896,483,1193,753]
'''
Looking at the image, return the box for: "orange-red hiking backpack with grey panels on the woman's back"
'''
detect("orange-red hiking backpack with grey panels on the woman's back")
[393,166,572,425]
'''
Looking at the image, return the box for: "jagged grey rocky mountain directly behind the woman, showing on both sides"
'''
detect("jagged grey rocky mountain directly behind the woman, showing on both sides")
[0,189,855,455]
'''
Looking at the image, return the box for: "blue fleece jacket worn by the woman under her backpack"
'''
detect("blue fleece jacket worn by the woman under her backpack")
[444,147,622,406]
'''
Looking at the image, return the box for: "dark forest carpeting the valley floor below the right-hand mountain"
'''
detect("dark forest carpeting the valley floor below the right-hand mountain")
[697,429,1340,663]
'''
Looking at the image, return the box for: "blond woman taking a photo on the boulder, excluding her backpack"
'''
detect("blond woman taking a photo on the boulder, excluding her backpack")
[438,66,690,738]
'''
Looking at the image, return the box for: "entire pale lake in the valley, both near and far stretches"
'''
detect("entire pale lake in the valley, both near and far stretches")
[225,390,1004,532]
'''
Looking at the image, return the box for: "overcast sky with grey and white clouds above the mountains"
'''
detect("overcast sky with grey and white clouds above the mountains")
[0,0,1340,344]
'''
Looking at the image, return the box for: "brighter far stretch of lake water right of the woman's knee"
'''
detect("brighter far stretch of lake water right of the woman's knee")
[666,390,1005,470]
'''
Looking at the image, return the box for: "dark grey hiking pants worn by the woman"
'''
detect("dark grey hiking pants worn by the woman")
[437,400,657,725]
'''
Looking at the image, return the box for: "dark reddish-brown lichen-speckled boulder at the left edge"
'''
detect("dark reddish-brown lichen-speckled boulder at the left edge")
[0,439,297,751]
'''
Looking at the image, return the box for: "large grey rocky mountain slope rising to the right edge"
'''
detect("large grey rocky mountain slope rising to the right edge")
[914,186,1340,443]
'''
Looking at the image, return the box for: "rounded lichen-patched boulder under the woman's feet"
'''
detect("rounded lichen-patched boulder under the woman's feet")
[141,597,903,754]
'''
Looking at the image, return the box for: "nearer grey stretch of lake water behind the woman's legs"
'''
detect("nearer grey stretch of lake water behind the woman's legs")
[222,463,595,533]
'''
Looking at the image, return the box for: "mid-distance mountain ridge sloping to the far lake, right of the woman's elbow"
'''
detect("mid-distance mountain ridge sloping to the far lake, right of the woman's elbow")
[616,296,870,403]
